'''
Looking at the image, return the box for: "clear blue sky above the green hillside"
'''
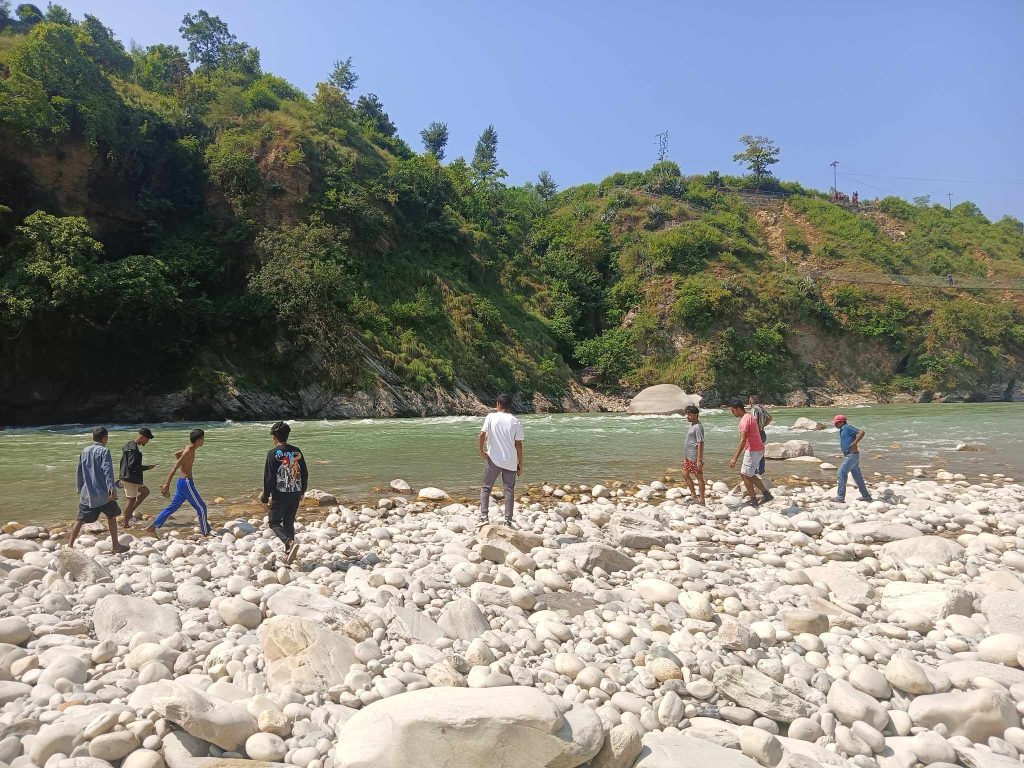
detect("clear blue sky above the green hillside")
[65,0,1024,218]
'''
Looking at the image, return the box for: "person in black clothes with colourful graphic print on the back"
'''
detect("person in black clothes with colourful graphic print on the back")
[260,421,309,564]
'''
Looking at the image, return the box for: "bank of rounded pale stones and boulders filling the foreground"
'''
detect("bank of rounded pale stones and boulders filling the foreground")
[0,476,1024,768]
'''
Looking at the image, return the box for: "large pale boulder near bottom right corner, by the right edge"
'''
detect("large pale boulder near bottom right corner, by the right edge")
[907,688,1020,743]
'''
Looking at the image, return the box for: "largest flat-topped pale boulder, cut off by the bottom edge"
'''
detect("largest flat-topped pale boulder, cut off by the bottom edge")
[334,686,604,768]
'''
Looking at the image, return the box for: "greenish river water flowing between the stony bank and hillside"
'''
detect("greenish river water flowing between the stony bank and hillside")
[0,403,1024,523]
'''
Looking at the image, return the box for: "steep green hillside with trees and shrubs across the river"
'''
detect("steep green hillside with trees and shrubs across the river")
[0,5,1024,424]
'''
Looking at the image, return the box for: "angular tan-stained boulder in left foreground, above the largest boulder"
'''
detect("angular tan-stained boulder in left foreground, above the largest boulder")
[259,616,355,694]
